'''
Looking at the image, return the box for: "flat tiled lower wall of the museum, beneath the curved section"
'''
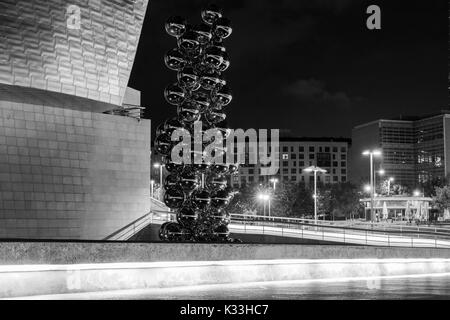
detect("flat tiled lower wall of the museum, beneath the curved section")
[0,101,150,240]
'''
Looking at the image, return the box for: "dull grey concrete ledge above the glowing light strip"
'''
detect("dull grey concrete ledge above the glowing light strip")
[0,241,450,265]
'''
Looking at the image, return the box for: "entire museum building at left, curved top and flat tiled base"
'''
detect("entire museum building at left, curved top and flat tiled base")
[0,0,150,240]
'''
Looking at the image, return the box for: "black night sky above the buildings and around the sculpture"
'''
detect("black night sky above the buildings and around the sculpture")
[129,0,448,137]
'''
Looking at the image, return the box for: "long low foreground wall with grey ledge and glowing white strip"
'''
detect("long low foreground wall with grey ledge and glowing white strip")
[0,242,450,299]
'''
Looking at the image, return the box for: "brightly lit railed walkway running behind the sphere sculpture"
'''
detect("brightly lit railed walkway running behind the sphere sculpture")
[104,204,450,248]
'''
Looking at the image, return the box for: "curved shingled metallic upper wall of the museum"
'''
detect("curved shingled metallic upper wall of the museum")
[0,0,147,105]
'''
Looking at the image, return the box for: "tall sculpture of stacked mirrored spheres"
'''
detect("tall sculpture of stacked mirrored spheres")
[155,5,238,242]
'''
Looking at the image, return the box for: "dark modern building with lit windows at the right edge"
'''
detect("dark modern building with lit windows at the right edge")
[350,111,450,186]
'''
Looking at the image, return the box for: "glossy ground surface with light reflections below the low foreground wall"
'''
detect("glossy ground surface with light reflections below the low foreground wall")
[9,273,450,300]
